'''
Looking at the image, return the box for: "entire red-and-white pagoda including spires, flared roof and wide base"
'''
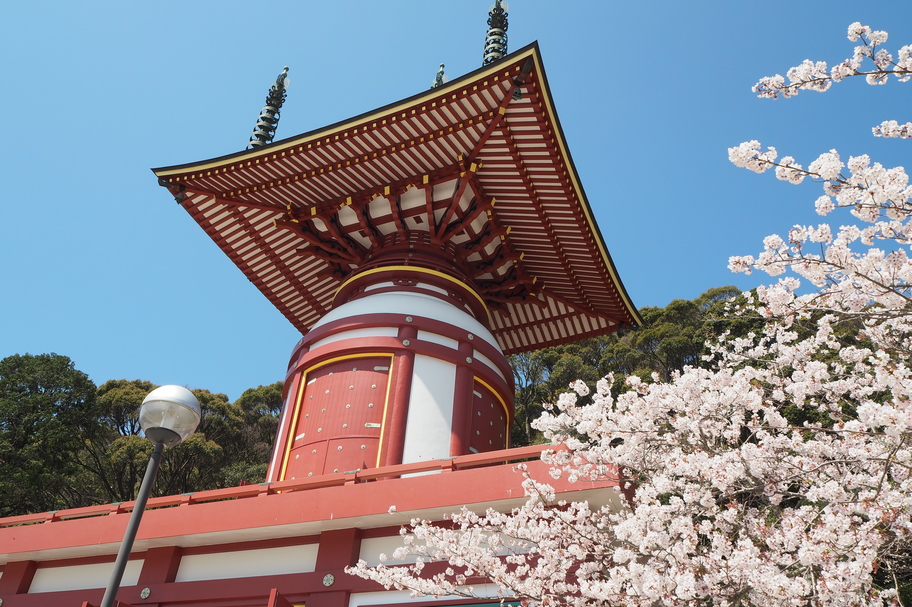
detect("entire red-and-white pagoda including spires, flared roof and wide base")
[0,1,640,607]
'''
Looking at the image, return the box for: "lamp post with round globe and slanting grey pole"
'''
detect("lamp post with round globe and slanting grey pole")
[101,386,200,607]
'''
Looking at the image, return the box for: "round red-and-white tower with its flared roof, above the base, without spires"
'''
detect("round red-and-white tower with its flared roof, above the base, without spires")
[155,45,638,481]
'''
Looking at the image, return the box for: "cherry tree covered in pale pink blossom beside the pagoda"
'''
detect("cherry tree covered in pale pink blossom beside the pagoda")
[350,23,912,607]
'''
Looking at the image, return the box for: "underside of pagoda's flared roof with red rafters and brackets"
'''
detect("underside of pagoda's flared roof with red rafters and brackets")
[155,44,640,354]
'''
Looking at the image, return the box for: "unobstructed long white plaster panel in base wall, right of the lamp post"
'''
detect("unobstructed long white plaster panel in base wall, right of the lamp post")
[174,544,317,582]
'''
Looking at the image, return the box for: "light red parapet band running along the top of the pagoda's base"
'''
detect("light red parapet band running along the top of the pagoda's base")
[0,446,600,560]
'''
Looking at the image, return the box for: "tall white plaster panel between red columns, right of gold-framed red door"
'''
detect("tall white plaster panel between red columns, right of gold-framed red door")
[402,354,456,464]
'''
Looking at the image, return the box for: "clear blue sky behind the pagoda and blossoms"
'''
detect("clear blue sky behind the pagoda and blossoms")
[0,0,912,399]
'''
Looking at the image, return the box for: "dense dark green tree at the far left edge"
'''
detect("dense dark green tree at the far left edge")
[0,354,101,516]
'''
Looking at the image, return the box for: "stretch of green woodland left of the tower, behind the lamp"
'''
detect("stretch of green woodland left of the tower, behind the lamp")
[0,354,282,516]
